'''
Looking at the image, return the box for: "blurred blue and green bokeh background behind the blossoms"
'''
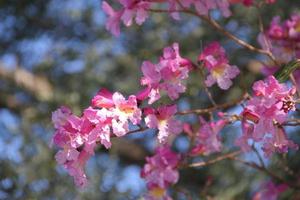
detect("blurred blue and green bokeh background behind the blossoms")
[0,0,300,200]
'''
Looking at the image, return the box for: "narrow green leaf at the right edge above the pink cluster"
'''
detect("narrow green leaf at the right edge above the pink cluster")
[275,59,300,83]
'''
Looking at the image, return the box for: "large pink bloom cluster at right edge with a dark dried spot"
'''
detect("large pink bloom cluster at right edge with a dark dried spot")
[236,76,298,156]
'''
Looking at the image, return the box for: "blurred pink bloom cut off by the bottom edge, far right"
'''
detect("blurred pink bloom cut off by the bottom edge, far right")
[252,181,288,200]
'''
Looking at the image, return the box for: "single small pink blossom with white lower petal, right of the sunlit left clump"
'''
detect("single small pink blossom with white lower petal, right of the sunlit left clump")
[144,105,182,143]
